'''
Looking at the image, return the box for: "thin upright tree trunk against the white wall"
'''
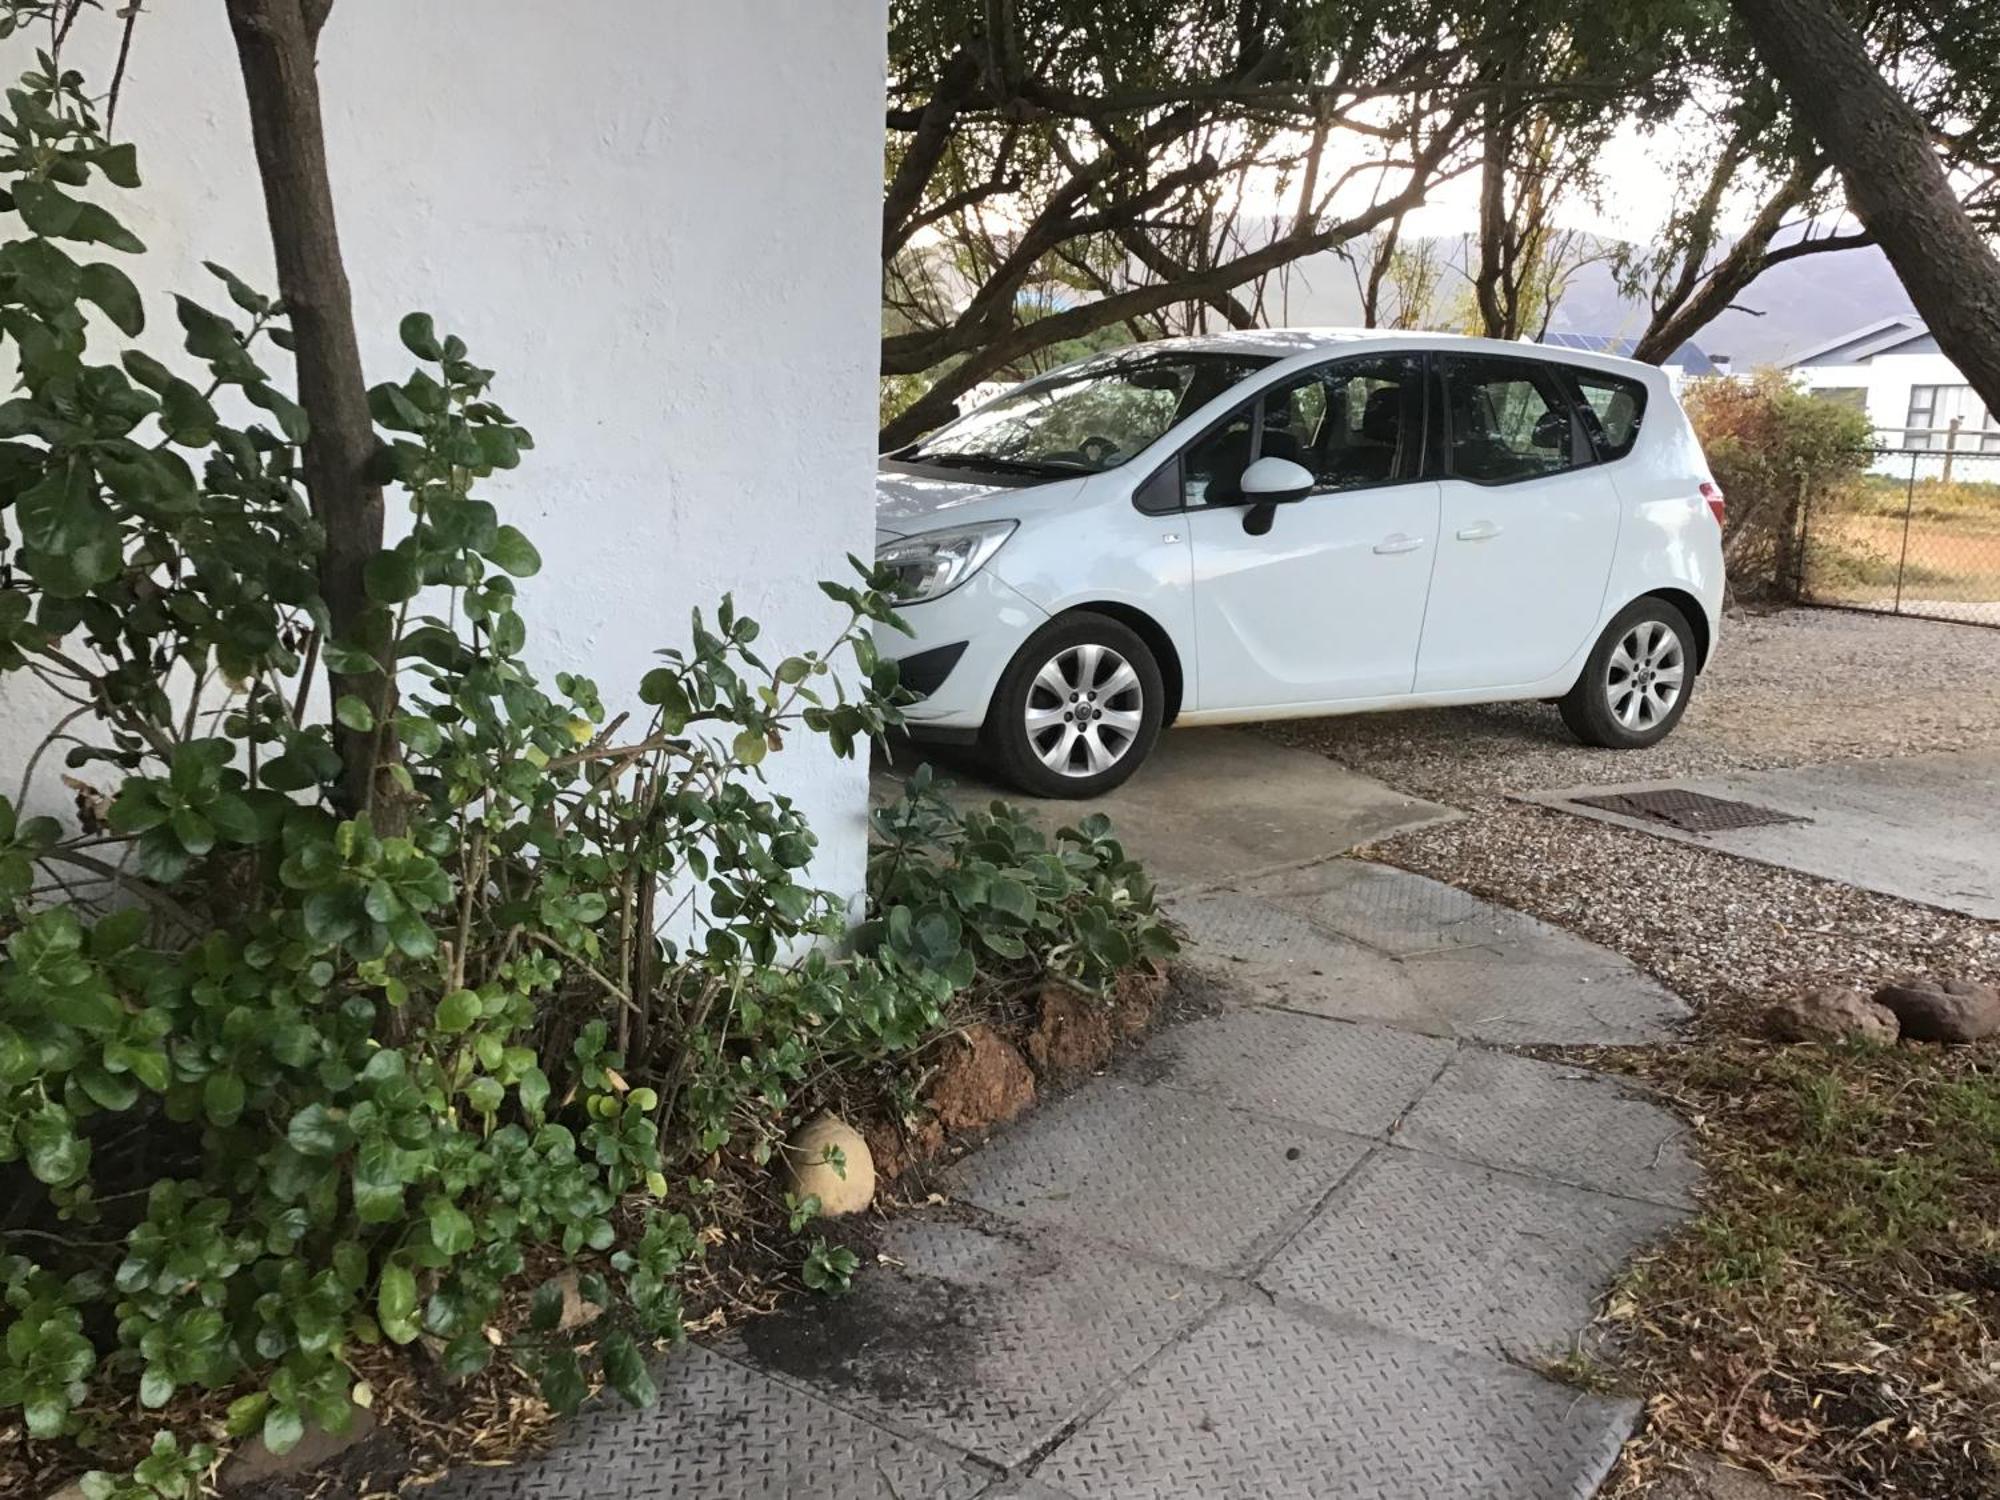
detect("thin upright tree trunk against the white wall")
[228,0,396,820]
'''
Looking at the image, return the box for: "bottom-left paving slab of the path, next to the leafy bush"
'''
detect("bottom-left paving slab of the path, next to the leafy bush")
[424,1348,994,1500]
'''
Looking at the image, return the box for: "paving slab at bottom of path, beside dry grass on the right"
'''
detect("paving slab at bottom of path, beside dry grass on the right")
[1036,1302,1638,1500]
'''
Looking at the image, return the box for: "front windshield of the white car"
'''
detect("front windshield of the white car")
[896,350,1270,476]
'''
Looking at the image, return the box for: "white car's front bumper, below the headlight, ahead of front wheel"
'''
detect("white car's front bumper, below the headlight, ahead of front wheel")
[874,568,1048,732]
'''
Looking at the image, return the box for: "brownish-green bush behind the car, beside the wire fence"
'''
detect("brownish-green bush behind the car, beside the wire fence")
[1684,370,1872,594]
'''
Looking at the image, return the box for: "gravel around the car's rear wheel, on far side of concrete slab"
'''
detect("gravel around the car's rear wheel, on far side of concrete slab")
[1264,610,2000,808]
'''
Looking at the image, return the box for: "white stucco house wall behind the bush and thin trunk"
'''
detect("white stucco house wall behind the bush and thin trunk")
[0,0,884,890]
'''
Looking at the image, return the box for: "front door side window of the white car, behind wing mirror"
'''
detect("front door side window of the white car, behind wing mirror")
[1180,354,1424,506]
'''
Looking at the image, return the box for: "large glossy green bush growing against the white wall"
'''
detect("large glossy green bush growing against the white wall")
[0,32,928,1494]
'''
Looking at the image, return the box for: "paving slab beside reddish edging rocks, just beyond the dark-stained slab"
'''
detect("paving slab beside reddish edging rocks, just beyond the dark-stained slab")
[946,1088,1370,1270]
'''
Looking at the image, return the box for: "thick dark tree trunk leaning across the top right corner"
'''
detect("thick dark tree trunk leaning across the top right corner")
[1730,0,2000,412]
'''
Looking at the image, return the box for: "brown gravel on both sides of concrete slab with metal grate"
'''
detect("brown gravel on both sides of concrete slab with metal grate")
[1266,610,2000,1026]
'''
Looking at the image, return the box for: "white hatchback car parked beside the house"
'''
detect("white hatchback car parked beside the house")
[876,330,1722,796]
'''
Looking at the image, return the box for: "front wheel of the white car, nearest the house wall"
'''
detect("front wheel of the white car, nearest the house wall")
[984,610,1166,798]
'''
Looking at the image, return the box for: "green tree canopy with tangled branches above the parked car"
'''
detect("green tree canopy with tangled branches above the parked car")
[882,0,2000,446]
